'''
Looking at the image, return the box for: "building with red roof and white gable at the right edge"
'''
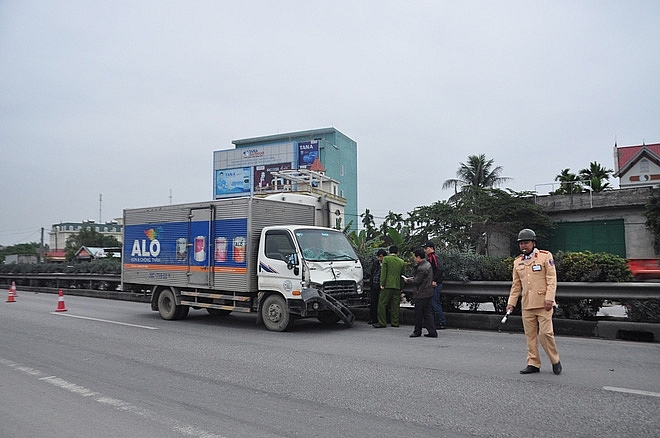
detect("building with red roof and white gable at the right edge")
[614,143,660,189]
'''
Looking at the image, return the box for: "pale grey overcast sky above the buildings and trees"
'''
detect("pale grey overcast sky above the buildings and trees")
[0,0,660,245]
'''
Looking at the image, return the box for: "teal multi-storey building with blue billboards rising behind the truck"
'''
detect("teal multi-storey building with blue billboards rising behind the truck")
[213,128,359,229]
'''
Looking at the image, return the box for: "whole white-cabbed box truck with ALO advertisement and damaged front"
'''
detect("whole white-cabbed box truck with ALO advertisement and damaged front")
[121,198,363,331]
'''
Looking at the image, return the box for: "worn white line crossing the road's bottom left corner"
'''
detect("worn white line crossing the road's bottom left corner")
[0,357,226,438]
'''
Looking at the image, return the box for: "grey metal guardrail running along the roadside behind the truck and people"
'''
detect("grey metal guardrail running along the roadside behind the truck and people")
[0,273,660,300]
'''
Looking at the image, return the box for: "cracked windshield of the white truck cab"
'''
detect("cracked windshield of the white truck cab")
[296,229,358,262]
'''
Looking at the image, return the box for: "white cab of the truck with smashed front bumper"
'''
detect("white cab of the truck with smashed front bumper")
[257,226,363,330]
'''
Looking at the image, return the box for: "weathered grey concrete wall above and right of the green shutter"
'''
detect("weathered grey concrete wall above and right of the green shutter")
[535,187,659,259]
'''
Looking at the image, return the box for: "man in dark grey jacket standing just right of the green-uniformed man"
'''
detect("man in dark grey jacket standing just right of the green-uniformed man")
[404,249,438,338]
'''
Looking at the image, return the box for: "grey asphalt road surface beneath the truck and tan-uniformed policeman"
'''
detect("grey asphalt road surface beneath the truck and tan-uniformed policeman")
[0,291,660,438]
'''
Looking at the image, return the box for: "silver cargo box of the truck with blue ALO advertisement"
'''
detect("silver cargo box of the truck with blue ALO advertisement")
[122,198,315,292]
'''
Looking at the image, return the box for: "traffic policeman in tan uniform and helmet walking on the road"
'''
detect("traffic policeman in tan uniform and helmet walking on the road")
[506,228,561,374]
